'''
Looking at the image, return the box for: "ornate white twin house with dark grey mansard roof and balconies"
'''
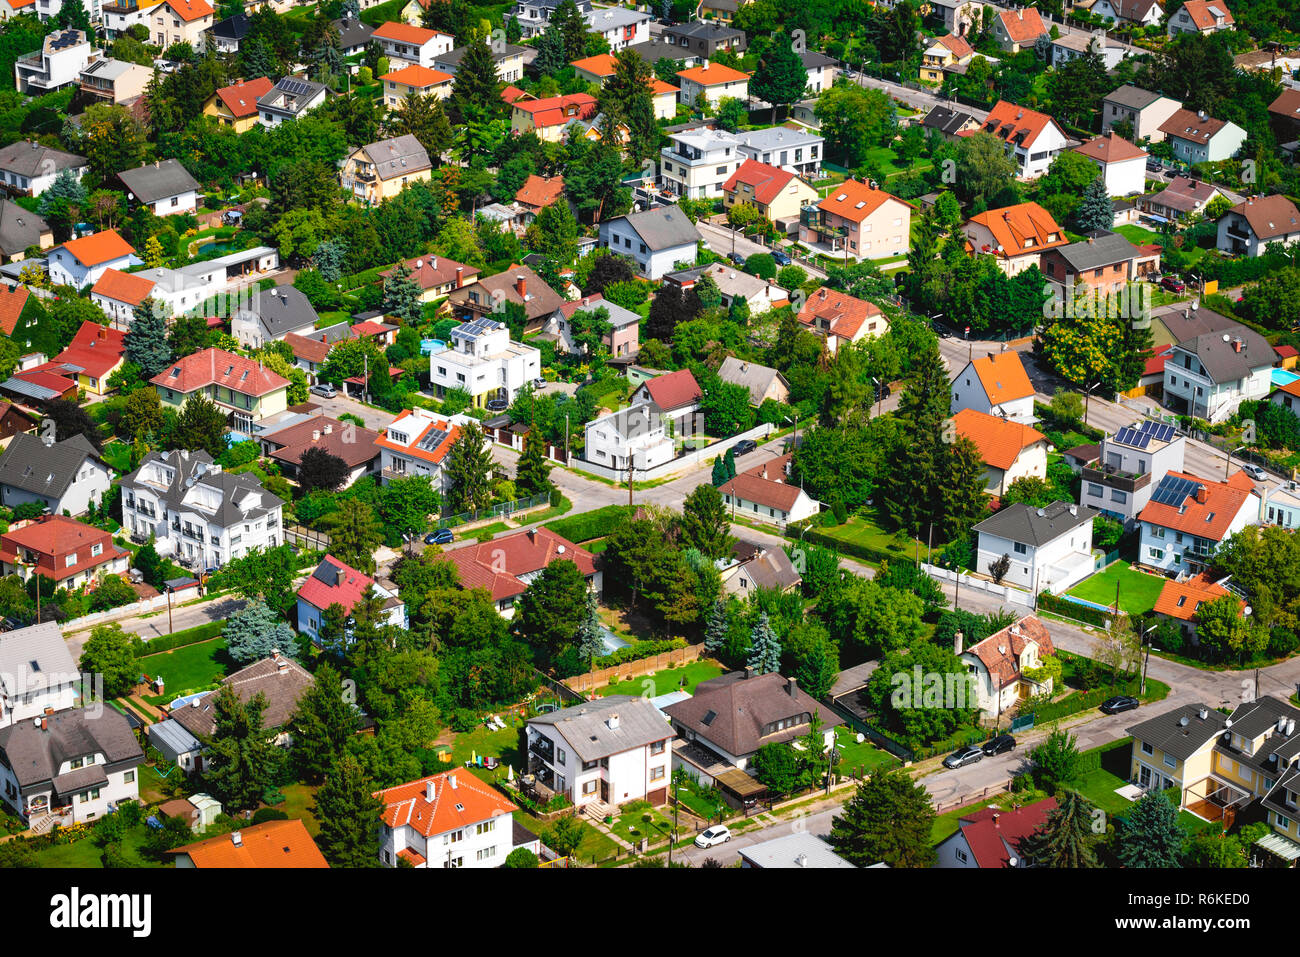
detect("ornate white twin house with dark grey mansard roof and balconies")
[121,449,285,571]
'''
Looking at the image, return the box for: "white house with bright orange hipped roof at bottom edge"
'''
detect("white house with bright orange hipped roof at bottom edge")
[374,771,541,867]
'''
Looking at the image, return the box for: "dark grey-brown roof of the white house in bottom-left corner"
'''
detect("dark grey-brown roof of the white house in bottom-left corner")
[0,707,144,792]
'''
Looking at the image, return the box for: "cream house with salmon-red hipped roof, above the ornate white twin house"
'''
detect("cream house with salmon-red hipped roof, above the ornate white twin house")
[150,348,289,433]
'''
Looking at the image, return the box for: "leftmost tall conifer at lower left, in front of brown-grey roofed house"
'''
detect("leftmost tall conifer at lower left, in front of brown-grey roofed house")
[203,684,283,811]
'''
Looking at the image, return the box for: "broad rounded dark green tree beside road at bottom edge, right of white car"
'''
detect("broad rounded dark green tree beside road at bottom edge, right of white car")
[829,768,935,867]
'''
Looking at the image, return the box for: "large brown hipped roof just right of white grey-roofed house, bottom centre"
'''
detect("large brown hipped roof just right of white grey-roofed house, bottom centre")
[663,671,844,757]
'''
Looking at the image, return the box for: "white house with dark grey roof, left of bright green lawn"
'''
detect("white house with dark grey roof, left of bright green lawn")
[974,502,1097,594]
